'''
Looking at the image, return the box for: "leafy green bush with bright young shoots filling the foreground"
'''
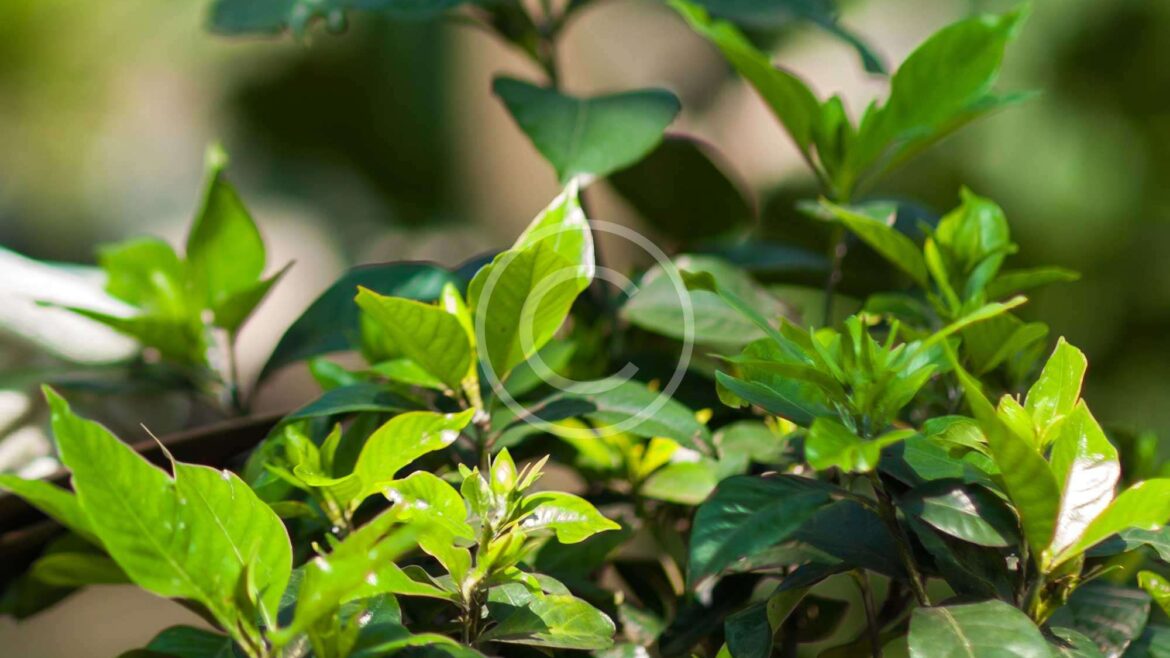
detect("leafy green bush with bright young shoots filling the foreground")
[0,0,1170,658]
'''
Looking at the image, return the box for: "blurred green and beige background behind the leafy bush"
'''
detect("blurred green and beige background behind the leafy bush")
[0,0,1170,657]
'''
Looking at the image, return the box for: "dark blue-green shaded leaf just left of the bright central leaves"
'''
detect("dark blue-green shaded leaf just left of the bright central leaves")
[261,262,455,378]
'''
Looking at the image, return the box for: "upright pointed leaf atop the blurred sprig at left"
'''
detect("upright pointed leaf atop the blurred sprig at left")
[187,146,264,310]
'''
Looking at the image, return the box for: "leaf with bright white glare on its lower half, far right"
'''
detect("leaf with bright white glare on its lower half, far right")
[1046,400,1121,553]
